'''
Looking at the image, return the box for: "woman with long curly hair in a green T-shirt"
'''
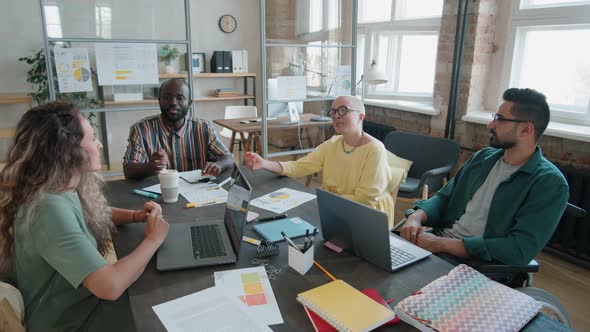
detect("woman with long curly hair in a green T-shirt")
[0,102,168,331]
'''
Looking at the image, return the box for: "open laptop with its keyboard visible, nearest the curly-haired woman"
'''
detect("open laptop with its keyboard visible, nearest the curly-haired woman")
[156,165,252,271]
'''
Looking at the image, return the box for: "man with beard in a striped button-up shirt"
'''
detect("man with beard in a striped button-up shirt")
[123,78,233,179]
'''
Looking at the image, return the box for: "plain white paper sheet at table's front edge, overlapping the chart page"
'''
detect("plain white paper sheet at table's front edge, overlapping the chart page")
[152,287,272,332]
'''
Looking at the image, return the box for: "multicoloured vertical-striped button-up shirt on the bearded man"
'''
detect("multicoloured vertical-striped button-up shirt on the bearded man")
[123,114,230,172]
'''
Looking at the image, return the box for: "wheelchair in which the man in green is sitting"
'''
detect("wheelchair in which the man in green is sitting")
[392,203,586,327]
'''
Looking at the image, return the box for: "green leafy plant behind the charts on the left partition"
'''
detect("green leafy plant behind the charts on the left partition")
[18,43,98,130]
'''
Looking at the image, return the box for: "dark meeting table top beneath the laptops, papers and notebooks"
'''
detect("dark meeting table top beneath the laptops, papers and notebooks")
[106,171,452,332]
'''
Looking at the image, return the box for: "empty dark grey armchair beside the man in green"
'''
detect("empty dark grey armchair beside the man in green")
[384,131,459,198]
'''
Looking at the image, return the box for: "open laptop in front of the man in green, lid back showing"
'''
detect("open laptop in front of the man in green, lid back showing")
[317,189,431,272]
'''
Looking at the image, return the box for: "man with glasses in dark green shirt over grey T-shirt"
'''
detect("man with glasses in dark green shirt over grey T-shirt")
[401,88,569,265]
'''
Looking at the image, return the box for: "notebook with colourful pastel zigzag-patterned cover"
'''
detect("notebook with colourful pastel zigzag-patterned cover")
[394,264,541,331]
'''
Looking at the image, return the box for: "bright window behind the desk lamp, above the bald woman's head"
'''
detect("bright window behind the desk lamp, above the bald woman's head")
[357,0,443,103]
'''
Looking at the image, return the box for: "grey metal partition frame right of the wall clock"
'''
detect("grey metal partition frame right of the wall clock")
[260,0,358,159]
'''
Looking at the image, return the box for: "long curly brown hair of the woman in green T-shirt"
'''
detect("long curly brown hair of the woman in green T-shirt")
[0,102,114,269]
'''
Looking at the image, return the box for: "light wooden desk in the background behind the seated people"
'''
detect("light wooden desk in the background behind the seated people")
[213,113,332,153]
